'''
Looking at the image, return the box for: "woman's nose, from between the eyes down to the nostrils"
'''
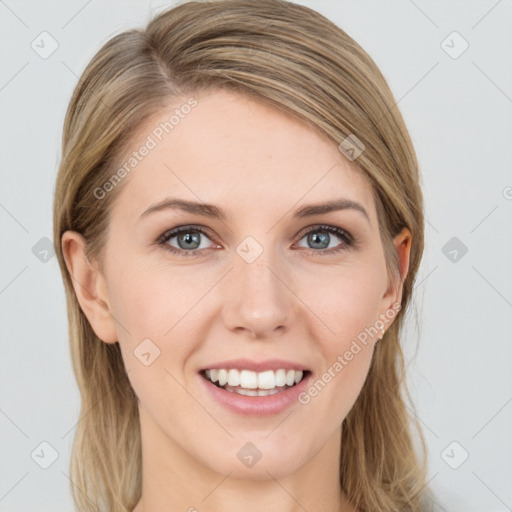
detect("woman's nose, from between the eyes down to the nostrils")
[222,251,294,340]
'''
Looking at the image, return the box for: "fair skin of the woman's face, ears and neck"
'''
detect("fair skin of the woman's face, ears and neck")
[62,91,411,512]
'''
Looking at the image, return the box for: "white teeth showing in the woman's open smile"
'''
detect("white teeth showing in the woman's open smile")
[205,368,304,390]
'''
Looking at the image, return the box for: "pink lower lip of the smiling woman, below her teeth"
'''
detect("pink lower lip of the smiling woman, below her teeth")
[199,373,311,416]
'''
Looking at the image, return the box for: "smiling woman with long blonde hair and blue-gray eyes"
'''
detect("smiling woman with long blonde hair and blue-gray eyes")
[54,0,438,512]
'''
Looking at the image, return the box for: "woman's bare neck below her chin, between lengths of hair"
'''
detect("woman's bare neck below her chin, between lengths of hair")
[133,408,352,512]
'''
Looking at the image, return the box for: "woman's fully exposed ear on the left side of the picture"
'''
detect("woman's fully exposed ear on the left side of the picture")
[61,231,117,343]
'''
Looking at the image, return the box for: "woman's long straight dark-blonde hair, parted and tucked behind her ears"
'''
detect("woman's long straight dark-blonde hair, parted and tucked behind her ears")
[54,0,431,512]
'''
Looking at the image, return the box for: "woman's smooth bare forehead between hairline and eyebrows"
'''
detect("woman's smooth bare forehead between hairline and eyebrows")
[110,90,373,222]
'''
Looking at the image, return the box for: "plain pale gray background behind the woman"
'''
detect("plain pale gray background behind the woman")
[0,0,512,512]
